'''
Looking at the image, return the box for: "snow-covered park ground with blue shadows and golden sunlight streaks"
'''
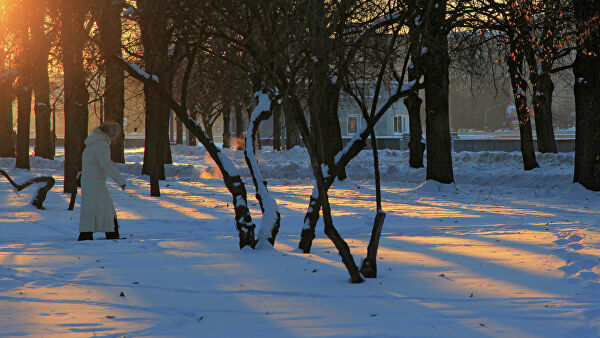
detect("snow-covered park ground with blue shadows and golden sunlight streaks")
[0,146,600,337]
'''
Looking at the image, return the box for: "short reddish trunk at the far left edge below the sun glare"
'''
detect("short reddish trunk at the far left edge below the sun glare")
[0,75,15,157]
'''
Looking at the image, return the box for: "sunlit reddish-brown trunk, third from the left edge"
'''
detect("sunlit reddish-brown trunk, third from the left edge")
[30,4,54,159]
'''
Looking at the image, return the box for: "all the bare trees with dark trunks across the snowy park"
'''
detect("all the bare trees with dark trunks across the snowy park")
[0,0,600,282]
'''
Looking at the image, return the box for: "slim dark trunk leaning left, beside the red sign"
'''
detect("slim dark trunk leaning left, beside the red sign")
[506,45,539,170]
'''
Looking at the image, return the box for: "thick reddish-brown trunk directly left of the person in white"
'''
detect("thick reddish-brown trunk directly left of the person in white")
[60,0,89,193]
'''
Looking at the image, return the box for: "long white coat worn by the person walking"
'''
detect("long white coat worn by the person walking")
[79,128,126,232]
